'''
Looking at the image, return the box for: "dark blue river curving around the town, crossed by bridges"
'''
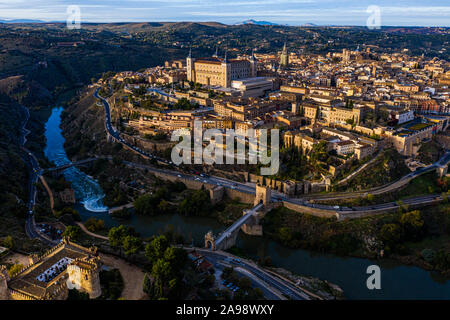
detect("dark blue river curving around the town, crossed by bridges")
[45,108,450,299]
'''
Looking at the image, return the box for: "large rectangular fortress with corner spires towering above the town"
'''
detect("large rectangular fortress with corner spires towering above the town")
[186,51,257,88]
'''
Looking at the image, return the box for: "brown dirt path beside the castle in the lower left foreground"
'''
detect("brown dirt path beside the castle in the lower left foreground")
[100,253,147,300]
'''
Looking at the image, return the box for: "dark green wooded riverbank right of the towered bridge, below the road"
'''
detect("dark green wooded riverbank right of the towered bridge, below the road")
[263,203,450,274]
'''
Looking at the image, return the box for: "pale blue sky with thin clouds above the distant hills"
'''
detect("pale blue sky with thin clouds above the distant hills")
[0,0,450,27]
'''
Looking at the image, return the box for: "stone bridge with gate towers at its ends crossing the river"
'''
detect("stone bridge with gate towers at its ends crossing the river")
[205,185,271,251]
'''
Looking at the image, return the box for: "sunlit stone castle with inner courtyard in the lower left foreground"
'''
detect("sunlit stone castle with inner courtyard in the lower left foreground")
[0,238,102,300]
